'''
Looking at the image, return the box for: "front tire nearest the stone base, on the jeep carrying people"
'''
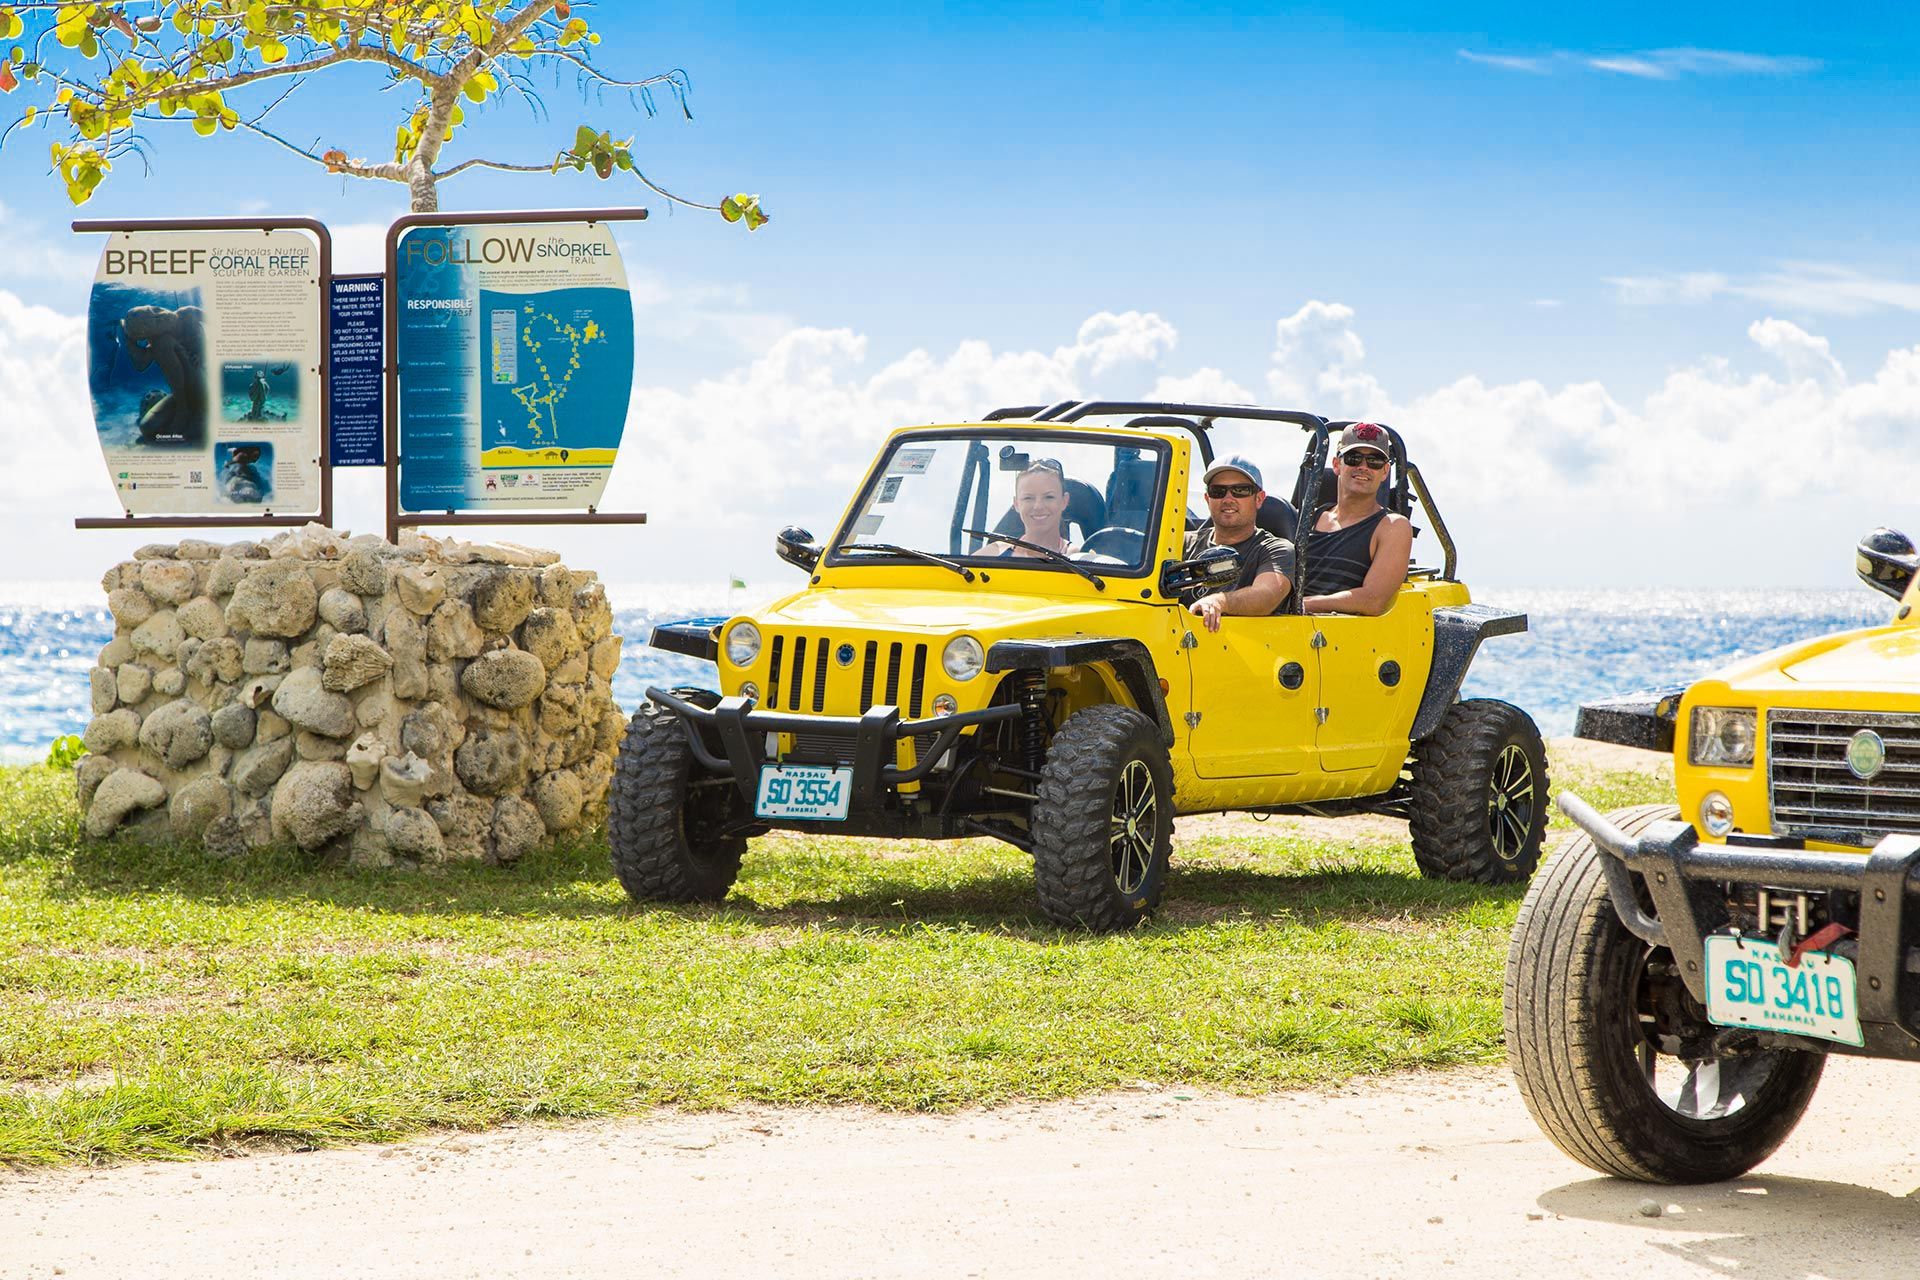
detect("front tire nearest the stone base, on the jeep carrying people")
[607,702,747,902]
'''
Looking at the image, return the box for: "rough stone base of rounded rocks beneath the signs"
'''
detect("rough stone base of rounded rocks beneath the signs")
[75,526,626,865]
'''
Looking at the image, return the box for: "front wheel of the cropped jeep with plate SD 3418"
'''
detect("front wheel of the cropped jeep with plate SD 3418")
[1503,804,1826,1182]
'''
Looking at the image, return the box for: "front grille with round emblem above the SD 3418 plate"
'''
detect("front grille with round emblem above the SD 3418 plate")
[1766,710,1920,848]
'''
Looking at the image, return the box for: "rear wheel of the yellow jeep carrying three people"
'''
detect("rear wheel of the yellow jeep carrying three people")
[1407,699,1548,885]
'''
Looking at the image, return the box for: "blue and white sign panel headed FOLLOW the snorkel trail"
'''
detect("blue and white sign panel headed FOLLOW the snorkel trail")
[392,223,634,512]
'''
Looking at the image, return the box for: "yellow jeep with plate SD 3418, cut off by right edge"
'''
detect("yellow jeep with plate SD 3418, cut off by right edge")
[1505,530,1920,1182]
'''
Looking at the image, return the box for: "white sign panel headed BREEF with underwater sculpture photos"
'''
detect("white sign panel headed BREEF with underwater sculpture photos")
[86,230,323,518]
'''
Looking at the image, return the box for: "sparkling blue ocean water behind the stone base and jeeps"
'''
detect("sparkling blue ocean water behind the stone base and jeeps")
[0,581,1893,764]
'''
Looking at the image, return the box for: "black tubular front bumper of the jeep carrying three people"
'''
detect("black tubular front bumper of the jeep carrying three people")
[647,687,1021,808]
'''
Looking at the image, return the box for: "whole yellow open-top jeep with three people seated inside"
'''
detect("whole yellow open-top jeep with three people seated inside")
[609,401,1548,929]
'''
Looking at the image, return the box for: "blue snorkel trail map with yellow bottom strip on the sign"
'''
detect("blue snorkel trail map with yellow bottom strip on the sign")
[480,288,634,470]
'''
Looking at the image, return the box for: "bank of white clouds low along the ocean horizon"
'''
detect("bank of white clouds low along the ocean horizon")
[0,290,1920,583]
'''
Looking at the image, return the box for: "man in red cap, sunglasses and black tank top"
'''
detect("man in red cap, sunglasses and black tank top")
[1300,422,1413,614]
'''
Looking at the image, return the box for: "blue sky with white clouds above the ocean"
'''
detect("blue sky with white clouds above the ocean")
[0,4,1920,585]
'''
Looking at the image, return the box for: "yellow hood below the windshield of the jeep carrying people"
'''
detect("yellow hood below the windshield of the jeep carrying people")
[751,580,1164,643]
